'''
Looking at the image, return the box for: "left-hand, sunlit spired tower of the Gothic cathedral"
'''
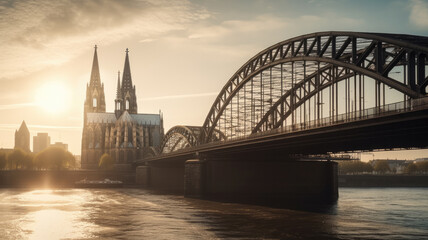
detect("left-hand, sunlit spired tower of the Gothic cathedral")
[84,45,106,123]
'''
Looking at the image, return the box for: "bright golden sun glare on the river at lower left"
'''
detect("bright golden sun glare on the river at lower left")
[1,190,96,239]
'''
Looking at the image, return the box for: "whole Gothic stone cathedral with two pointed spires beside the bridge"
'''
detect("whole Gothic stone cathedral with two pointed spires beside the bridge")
[82,46,164,169]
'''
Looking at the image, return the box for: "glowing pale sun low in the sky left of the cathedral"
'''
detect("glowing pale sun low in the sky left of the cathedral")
[35,82,71,114]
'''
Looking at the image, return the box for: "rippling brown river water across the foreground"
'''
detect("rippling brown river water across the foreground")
[0,188,428,239]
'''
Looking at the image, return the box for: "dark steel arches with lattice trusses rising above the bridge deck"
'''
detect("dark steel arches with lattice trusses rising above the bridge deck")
[160,32,428,153]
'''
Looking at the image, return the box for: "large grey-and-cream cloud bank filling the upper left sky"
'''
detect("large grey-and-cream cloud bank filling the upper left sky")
[0,0,209,78]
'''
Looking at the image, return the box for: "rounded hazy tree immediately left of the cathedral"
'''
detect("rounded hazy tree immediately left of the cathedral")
[34,147,76,170]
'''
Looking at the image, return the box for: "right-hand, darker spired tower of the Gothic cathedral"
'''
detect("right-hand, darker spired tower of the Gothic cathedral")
[115,49,138,118]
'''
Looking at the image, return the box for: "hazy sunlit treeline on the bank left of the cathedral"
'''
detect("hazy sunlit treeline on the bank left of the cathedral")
[0,147,76,170]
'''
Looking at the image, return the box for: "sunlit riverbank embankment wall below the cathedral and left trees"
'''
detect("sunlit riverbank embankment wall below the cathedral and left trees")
[0,170,135,188]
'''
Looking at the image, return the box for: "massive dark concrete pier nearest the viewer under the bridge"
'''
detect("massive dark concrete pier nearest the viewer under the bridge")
[184,159,338,206]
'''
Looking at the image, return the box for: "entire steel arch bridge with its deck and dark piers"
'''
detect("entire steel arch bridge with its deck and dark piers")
[136,32,428,205]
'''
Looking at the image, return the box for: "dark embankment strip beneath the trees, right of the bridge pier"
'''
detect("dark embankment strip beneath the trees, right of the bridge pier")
[339,174,428,187]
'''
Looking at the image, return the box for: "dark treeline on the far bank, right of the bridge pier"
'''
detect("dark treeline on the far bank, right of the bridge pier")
[339,161,428,174]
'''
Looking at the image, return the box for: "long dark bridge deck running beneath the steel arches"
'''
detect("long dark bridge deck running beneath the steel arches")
[136,105,428,165]
